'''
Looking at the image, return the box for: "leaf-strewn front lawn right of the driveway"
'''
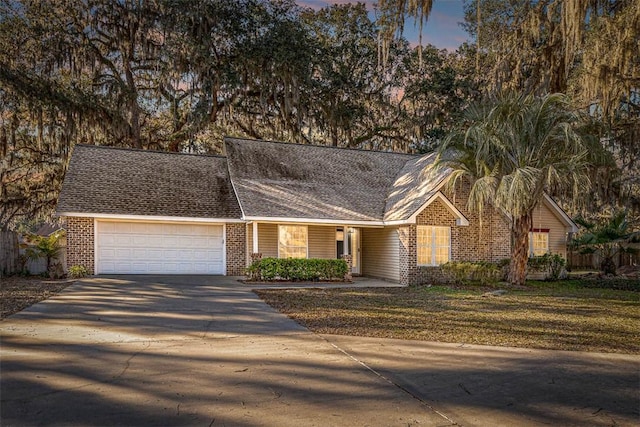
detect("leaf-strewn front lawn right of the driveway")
[256,280,640,354]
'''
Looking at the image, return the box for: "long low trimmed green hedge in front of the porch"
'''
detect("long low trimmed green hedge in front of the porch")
[247,258,349,281]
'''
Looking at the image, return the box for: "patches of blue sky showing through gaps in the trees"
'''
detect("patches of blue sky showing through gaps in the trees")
[297,0,468,51]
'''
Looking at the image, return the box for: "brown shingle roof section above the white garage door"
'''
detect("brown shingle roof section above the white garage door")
[57,145,242,218]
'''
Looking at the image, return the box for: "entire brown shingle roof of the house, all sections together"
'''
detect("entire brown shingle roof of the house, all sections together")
[57,138,446,222]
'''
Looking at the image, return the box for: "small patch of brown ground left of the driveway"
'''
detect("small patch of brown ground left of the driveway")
[0,276,74,319]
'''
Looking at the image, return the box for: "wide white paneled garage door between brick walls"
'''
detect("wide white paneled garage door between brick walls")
[96,221,225,274]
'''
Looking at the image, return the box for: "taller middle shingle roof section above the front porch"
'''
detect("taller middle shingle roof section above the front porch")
[225,138,417,221]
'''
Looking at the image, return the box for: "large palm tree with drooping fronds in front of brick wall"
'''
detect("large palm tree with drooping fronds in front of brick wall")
[438,93,589,285]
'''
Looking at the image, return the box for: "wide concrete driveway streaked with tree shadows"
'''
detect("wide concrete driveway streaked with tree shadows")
[0,276,640,426]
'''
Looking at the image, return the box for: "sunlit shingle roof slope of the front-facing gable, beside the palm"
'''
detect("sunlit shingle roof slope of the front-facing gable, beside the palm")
[384,153,448,221]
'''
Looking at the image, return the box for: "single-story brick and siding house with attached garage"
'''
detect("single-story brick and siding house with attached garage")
[57,137,576,284]
